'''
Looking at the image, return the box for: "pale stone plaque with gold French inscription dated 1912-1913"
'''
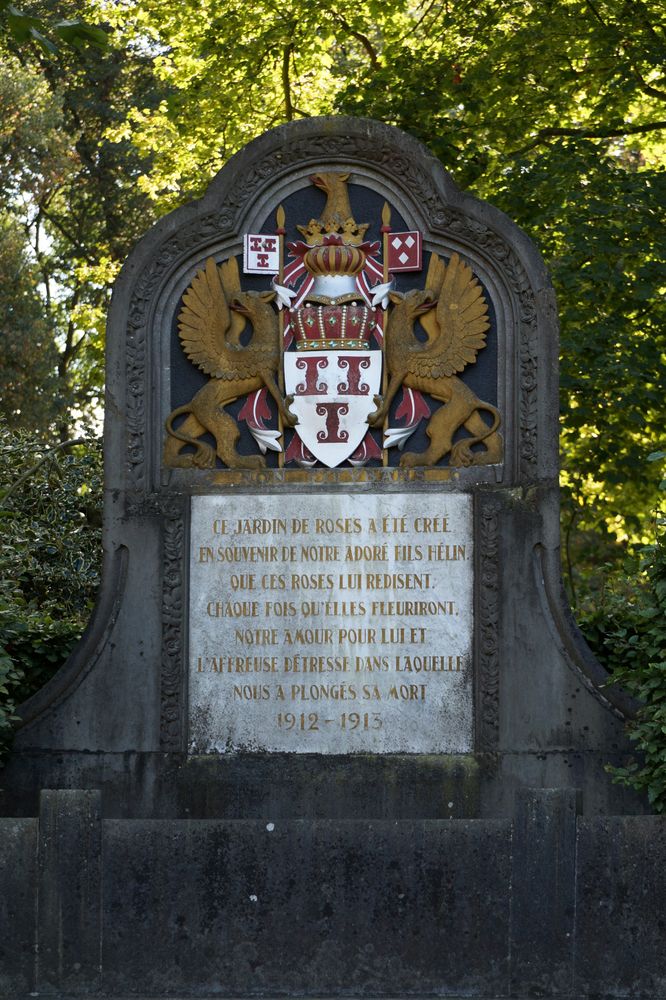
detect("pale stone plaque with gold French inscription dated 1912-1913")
[189,493,473,753]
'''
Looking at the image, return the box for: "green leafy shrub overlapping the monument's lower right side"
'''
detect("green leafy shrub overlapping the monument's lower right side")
[579,452,666,813]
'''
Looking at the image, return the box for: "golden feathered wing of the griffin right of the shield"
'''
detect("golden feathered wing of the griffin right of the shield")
[418,253,490,378]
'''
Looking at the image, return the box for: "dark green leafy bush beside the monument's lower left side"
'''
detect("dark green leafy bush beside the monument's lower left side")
[0,425,102,747]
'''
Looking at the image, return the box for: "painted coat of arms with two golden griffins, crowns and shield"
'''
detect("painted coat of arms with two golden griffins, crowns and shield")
[164,173,502,469]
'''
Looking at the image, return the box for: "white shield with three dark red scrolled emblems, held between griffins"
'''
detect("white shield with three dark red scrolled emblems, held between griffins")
[284,350,382,469]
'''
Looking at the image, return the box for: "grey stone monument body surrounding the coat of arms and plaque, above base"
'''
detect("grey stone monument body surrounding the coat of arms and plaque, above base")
[2,119,641,818]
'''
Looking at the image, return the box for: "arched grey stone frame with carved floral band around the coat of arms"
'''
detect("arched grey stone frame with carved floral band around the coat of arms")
[107,119,557,508]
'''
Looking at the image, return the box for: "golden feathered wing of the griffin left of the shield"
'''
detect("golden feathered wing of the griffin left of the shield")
[178,257,245,378]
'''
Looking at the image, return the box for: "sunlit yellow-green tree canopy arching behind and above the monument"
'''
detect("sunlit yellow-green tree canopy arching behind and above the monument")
[0,0,666,552]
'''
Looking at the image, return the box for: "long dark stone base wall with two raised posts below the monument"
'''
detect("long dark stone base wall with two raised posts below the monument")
[0,789,666,1000]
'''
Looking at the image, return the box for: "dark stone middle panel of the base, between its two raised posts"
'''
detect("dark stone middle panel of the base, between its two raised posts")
[104,816,510,996]
